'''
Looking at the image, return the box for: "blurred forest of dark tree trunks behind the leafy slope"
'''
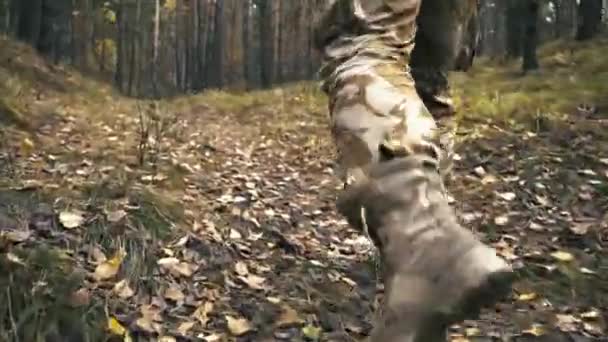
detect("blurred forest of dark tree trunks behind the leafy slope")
[0,0,608,97]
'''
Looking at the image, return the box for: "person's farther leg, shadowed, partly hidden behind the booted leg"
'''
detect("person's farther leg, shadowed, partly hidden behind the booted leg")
[410,0,479,181]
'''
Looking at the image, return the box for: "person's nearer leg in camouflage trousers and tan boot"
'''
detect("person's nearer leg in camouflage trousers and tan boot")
[316,0,512,342]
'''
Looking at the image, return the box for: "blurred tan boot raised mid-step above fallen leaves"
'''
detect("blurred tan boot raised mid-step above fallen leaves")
[338,155,514,342]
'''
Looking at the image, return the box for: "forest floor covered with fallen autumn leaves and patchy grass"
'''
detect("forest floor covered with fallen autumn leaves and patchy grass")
[0,38,608,342]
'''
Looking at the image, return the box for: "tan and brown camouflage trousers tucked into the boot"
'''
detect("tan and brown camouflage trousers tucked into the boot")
[316,0,476,324]
